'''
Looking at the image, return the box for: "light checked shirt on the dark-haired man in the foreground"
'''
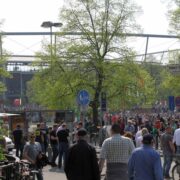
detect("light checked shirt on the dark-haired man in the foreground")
[100,134,135,163]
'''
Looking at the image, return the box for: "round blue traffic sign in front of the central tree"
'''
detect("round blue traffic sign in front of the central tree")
[77,90,90,106]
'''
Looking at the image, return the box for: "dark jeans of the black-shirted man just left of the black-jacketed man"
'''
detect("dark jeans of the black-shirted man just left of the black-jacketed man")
[58,142,69,168]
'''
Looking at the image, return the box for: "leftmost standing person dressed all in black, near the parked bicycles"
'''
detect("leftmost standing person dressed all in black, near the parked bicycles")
[12,124,24,159]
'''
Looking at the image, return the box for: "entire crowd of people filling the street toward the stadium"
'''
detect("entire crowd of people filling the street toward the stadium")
[2,112,180,180]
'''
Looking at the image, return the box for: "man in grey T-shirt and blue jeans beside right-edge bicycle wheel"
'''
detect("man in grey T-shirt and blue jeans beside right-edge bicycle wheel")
[161,126,175,179]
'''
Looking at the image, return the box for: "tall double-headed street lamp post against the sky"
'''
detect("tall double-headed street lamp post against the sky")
[41,21,63,63]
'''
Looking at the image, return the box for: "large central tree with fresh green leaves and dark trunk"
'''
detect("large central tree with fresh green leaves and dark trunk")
[29,0,150,122]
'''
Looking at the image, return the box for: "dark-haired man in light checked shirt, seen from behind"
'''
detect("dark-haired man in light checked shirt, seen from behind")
[99,124,135,180]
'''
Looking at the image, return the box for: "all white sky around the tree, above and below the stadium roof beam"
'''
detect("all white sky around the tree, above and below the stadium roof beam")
[0,0,177,63]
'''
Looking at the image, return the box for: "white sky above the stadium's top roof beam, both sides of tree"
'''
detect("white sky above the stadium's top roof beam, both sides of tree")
[0,0,168,34]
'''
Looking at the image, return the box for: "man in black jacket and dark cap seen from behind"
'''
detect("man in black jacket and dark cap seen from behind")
[64,128,100,180]
